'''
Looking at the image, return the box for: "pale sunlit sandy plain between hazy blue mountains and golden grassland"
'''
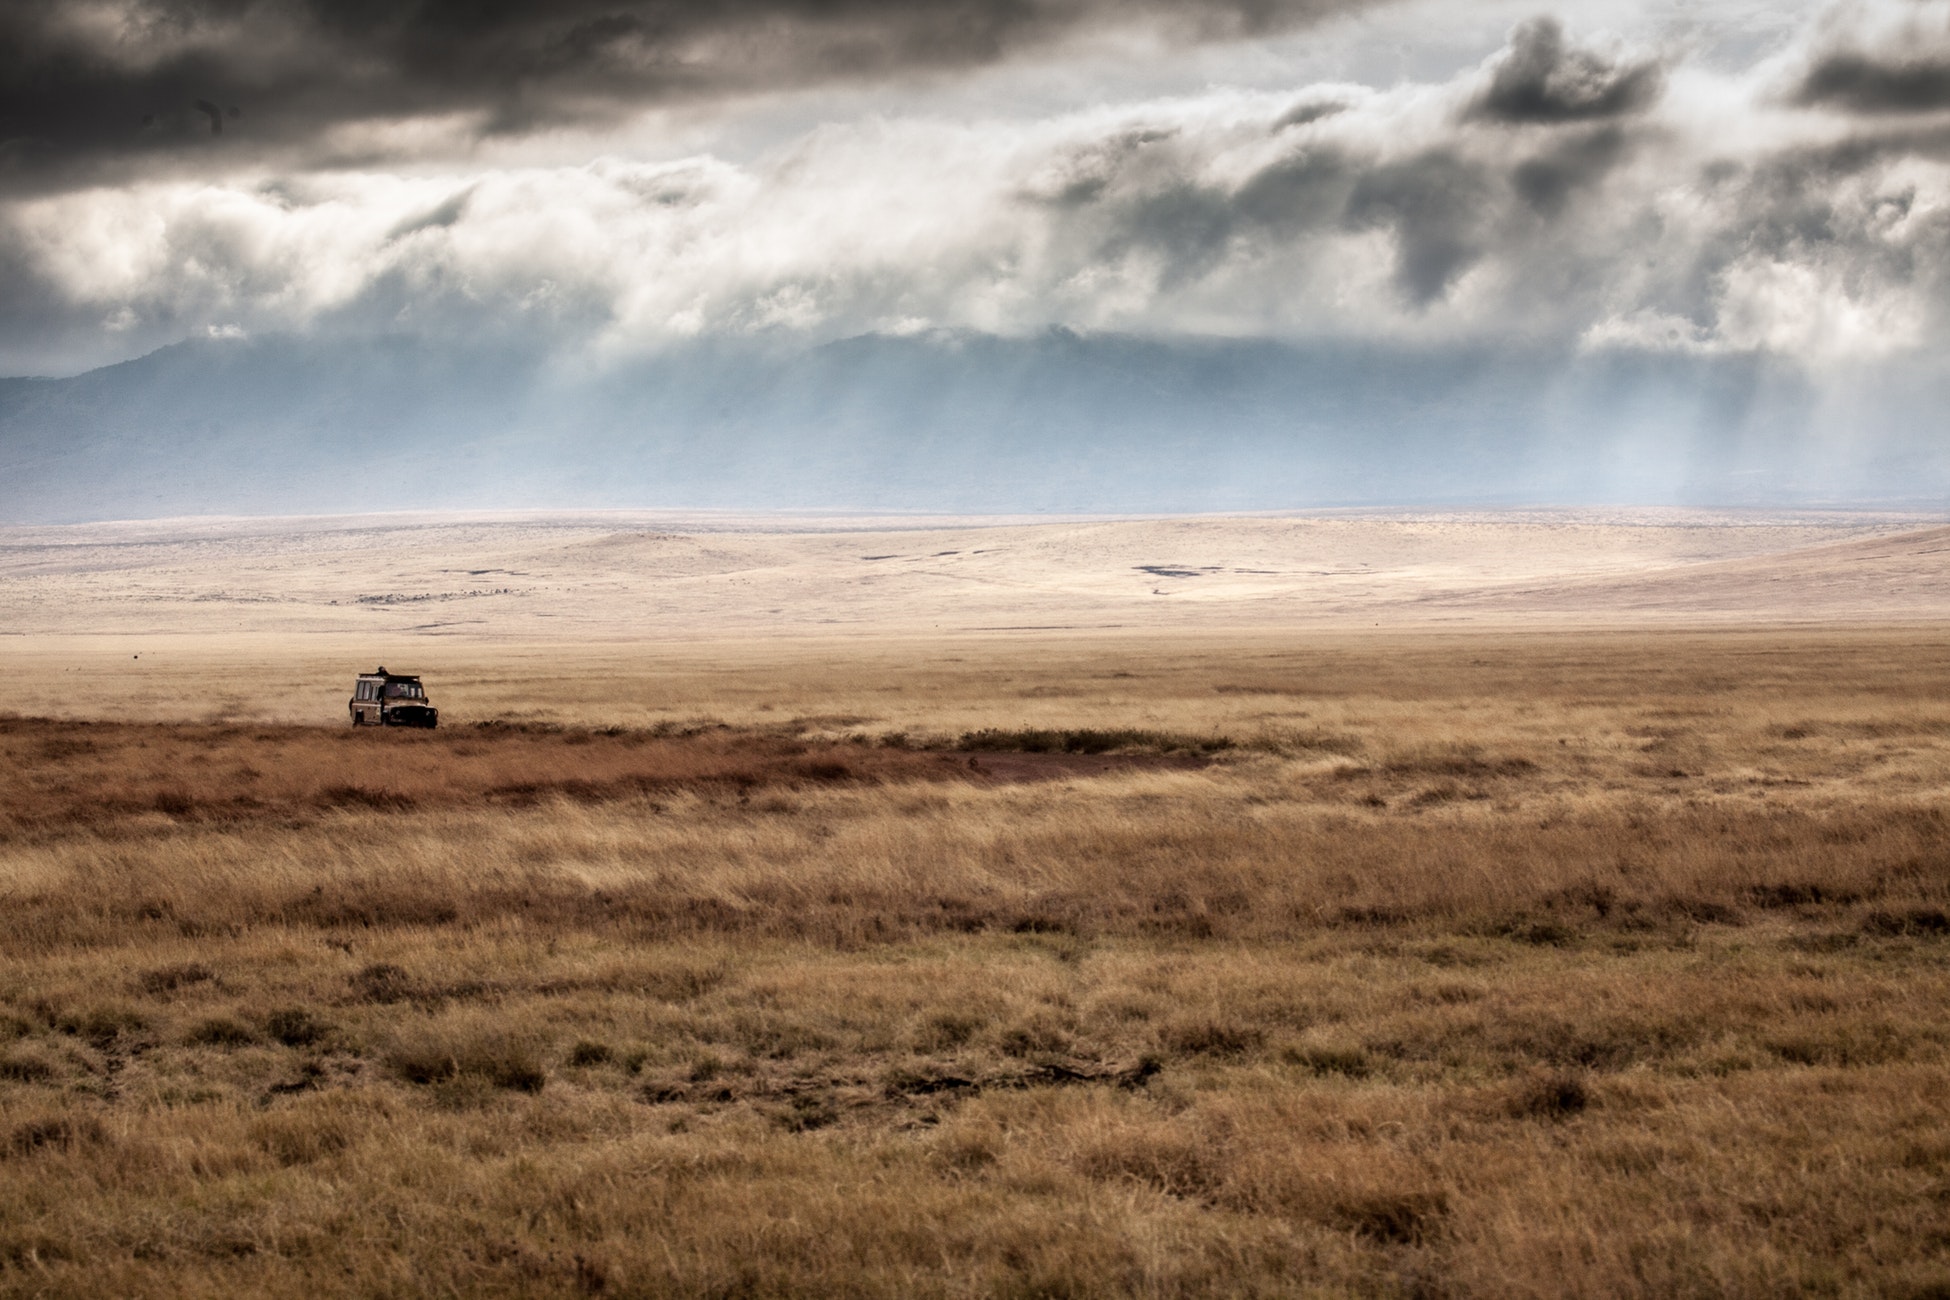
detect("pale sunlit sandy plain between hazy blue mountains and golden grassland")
[0,511,1950,639]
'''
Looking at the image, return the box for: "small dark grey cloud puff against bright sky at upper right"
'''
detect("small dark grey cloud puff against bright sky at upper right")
[1470,18,1665,123]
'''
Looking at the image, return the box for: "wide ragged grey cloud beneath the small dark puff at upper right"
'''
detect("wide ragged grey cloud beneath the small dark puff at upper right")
[1026,56,1646,312]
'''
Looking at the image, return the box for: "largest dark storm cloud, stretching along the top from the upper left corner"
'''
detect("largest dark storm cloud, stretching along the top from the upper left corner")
[0,0,1379,187]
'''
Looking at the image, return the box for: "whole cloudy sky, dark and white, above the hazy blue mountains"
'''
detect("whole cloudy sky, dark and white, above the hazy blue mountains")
[0,0,1950,514]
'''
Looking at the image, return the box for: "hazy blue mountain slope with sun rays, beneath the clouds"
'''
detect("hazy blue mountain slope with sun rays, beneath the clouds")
[0,331,1950,522]
